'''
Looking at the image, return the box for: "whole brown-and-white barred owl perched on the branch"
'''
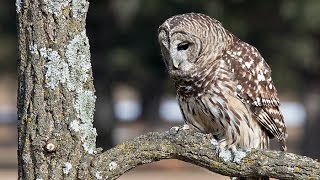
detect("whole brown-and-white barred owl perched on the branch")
[158,13,287,151]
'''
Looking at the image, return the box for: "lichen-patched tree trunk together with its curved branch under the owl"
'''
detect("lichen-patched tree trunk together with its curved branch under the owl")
[16,0,320,180]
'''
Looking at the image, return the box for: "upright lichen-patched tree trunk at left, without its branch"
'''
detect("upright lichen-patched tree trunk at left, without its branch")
[16,0,96,179]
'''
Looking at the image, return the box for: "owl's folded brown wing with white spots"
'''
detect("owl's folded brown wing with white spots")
[225,40,286,149]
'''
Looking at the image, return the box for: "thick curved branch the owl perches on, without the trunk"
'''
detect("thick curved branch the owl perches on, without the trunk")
[86,130,320,179]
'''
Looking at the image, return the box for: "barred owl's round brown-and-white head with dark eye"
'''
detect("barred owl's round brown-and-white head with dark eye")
[158,13,228,76]
